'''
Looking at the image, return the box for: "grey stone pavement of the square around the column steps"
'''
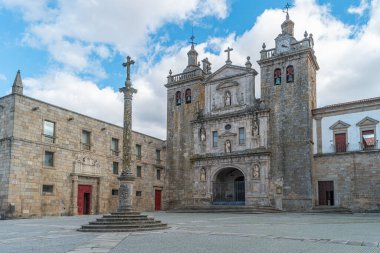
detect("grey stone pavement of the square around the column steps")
[0,212,380,253]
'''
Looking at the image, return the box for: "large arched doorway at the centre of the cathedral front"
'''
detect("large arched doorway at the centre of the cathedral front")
[213,168,245,205]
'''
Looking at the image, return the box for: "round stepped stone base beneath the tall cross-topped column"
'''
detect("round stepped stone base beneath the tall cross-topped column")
[78,212,168,232]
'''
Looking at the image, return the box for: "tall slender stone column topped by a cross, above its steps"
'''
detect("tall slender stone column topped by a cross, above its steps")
[118,56,137,212]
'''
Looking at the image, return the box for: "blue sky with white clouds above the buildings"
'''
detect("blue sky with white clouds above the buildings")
[0,0,380,139]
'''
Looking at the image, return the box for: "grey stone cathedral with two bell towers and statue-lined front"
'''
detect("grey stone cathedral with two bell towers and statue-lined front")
[166,15,319,210]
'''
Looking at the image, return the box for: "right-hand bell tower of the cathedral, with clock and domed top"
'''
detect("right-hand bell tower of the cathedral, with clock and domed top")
[258,12,319,210]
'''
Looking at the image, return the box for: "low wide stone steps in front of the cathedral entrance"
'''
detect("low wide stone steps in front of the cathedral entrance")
[169,205,281,213]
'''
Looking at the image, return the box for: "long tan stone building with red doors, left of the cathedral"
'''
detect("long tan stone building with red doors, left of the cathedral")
[0,72,166,217]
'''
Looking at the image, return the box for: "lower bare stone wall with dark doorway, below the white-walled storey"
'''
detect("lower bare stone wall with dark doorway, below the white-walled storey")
[313,150,380,212]
